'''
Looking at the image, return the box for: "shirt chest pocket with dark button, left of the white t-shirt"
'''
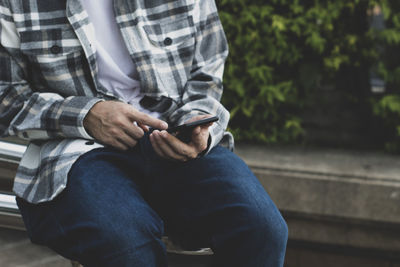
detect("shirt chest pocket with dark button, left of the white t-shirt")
[20,27,90,96]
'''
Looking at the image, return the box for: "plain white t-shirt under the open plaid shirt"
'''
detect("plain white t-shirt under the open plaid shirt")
[82,0,160,117]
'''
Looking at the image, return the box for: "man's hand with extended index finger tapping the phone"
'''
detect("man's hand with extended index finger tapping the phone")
[83,101,168,150]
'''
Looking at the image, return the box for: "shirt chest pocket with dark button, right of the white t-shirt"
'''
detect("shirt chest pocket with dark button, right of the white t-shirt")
[136,14,196,99]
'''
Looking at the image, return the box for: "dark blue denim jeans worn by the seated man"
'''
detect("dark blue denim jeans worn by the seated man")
[17,136,288,267]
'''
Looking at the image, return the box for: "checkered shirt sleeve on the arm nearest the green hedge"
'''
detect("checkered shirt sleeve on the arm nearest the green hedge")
[170,0,229,151]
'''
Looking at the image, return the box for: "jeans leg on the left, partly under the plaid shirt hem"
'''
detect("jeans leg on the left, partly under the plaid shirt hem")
[17,148,167,267]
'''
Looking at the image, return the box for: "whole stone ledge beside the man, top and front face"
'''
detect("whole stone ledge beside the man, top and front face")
[236,145,400,258]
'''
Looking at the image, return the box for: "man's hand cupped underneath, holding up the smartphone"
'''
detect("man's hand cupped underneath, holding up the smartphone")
[150,115,212,162]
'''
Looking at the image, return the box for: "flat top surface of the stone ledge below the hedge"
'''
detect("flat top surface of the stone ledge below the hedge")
[235,144,400,182]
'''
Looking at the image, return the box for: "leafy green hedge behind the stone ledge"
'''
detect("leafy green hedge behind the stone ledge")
[217,0,400,151]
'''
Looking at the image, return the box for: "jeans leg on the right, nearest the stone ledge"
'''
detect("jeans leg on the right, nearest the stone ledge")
[150,146,288,267]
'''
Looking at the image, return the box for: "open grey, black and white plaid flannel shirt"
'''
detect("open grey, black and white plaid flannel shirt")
[0,0,233,203]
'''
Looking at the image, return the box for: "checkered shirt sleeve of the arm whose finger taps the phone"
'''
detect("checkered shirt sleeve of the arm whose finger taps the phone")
[0,0,100,140]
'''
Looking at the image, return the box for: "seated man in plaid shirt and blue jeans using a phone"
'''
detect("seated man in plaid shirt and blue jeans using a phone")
[0,0,287,267]
